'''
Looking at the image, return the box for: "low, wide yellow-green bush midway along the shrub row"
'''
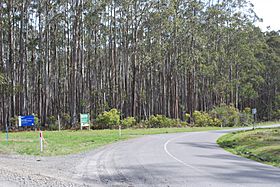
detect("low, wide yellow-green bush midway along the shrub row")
[146,115,181,128]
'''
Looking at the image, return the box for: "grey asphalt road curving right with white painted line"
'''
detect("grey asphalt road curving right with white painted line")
[73,125,280,187]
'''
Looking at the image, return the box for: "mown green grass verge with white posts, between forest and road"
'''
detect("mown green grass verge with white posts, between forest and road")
[0,127,223,156]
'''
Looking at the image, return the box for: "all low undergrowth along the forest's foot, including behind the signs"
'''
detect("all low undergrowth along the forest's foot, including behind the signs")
[6,104,258,131]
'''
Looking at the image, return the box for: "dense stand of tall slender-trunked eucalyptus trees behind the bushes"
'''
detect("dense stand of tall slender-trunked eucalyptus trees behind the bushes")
[0,0,280,127]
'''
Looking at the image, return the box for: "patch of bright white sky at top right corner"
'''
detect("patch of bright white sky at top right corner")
[250,0,280,31]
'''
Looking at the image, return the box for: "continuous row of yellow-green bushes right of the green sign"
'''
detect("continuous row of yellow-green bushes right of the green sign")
[70,104,253,129]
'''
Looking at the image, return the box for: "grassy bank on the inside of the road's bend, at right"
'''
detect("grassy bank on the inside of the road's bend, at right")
[217,128,280,167]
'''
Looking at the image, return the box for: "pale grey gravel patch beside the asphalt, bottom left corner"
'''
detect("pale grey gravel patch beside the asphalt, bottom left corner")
[0,154,86,187]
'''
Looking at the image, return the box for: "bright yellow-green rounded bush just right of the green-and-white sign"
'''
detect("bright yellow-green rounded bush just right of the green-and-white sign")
[96,108,120,128]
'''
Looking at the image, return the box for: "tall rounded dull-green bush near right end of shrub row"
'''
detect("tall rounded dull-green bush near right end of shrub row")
[210,104,240,127]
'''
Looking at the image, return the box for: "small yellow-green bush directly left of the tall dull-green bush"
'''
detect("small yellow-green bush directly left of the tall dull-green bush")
[193,111,221,127]
